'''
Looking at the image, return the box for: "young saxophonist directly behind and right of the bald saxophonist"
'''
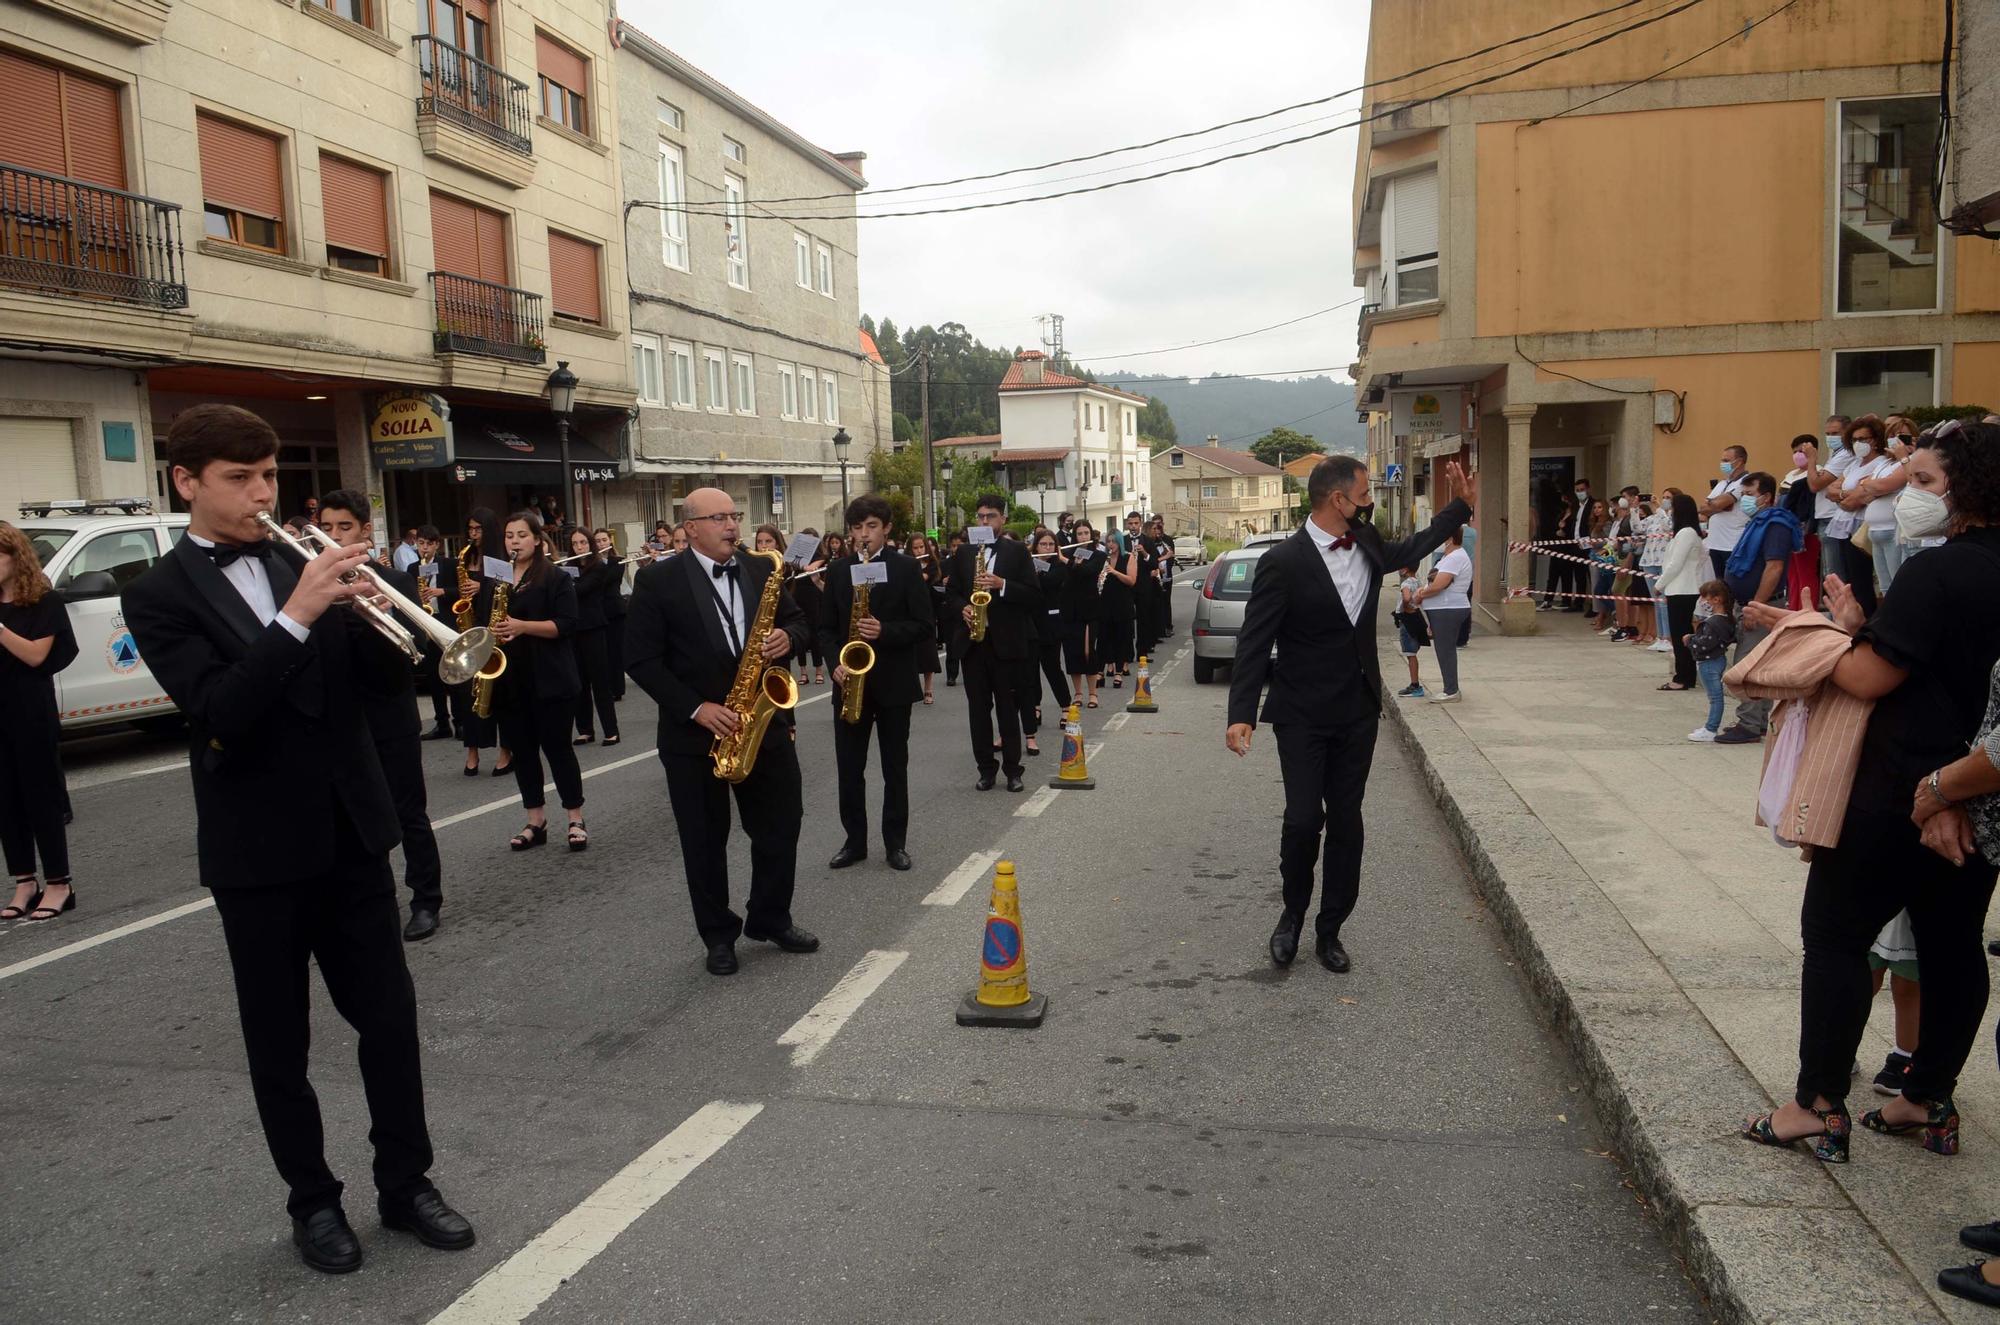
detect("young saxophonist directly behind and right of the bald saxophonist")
[820,492,938,869]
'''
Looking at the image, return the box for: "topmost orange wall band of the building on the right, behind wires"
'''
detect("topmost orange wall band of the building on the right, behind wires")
[1368,0,1944,102]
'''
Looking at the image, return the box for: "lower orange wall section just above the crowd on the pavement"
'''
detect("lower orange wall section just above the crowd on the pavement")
[1536,350,1826,492]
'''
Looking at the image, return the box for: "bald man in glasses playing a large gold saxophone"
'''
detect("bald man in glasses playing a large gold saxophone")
[626,488,820,975]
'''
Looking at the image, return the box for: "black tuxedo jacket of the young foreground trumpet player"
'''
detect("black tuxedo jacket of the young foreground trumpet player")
[122,538,410,889]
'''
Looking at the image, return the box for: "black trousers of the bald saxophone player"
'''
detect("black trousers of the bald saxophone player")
[660,729,804,947]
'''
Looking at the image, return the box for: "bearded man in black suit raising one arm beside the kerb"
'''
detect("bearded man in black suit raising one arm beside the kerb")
[1224,456,1472,971]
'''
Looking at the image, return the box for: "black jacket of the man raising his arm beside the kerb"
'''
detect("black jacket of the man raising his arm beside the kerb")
[1230,502,1472,727]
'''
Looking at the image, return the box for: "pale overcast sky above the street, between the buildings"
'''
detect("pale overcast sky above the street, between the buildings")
[618,0,1368,380]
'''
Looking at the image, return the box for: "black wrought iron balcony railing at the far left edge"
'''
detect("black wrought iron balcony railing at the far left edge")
[0,164,188,308]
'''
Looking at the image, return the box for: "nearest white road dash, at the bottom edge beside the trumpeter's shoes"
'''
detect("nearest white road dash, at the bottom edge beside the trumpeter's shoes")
[430,1099,764,1325]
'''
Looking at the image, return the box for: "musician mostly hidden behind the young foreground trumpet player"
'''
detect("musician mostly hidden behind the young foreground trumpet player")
[320,488,444,943]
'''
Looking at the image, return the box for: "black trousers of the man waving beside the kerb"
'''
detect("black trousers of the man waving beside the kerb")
[1272,713,1382,939]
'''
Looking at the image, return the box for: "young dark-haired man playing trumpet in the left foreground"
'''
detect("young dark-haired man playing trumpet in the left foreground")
[122,404,474,1273]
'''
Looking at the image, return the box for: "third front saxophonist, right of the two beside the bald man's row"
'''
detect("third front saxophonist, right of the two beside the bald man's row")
[944,492,1042,791]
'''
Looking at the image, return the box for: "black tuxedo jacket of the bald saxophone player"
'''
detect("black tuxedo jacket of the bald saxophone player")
[626,552,810,755]
